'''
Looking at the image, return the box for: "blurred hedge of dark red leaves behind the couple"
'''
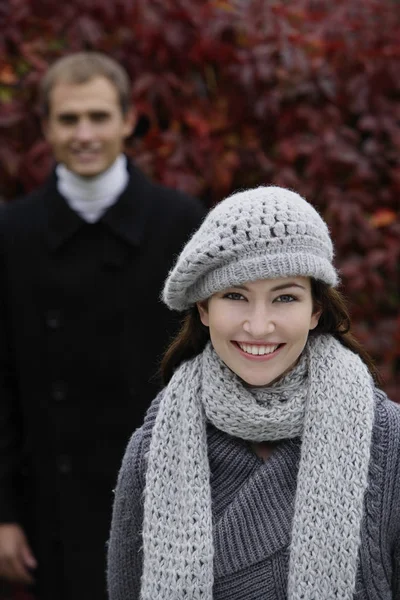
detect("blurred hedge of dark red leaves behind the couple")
[0,0,400,400]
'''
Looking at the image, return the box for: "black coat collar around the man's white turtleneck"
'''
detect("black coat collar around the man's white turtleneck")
[45,161,155,250]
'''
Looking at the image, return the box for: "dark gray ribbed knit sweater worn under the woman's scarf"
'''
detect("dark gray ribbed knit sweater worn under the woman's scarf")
[108,391,400,600]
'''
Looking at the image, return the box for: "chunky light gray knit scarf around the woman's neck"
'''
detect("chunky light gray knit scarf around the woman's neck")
[141,335,374,600]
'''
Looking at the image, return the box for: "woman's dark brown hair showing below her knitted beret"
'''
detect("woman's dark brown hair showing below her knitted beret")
[161,279,380,384]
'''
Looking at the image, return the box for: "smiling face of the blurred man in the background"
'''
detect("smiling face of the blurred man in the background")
[43,77,134,177]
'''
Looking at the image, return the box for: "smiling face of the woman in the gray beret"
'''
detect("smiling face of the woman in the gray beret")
[197,277,320,386]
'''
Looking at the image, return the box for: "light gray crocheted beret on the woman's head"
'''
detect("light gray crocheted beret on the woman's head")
[163,186,338,310]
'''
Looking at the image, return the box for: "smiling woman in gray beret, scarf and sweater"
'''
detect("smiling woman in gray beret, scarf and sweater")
[108,187,400,600]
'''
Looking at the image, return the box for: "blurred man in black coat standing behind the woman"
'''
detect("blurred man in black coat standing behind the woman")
[0,53,205,600]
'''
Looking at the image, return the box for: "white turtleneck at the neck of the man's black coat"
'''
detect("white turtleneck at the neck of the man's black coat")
[56,154,129,223]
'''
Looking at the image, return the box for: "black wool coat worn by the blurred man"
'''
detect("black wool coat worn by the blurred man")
[0,165,205,600]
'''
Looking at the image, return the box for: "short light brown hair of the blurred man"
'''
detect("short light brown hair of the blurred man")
[40,52,131,117]
